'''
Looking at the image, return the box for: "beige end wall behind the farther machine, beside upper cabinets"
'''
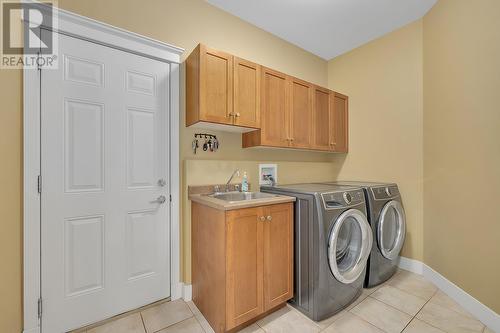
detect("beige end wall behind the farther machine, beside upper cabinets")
[328,20,423,260]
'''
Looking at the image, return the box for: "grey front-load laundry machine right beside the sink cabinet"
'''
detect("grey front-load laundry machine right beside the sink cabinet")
[261,184,373,321]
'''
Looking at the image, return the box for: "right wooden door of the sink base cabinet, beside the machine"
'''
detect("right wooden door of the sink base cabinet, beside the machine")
[264,204,293,311]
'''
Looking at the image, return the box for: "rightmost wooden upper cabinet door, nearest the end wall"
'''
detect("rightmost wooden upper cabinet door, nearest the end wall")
[330,92,349,153]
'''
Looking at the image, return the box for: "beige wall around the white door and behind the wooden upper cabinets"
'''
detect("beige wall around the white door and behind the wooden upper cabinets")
[0,0,330,332]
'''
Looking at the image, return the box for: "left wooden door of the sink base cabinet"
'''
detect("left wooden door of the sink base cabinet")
[226,207,264,330]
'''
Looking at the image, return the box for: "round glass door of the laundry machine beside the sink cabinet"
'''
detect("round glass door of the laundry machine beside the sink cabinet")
[328,209,373,283]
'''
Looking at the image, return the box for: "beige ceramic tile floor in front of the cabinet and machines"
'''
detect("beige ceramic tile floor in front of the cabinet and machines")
[77,271,493,333]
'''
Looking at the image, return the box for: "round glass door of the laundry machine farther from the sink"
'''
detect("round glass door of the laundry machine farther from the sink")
[377,200,406,260]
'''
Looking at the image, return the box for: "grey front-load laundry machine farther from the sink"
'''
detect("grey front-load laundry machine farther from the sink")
[328,181,406,288]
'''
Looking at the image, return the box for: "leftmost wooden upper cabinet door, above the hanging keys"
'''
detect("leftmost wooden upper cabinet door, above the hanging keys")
[199,45,233,125]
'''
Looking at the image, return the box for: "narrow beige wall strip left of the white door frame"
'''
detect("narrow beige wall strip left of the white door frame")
[0,70,23,333]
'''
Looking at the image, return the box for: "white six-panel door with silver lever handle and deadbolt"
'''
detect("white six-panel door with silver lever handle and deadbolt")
[41,32,170,333]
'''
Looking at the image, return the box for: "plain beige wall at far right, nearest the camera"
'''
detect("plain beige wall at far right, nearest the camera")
[424,0,500,313]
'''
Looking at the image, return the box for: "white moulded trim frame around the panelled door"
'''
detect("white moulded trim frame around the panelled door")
[23,0,184,333]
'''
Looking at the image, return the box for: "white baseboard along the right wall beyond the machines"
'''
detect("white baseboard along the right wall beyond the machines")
[398,257,500,332]
